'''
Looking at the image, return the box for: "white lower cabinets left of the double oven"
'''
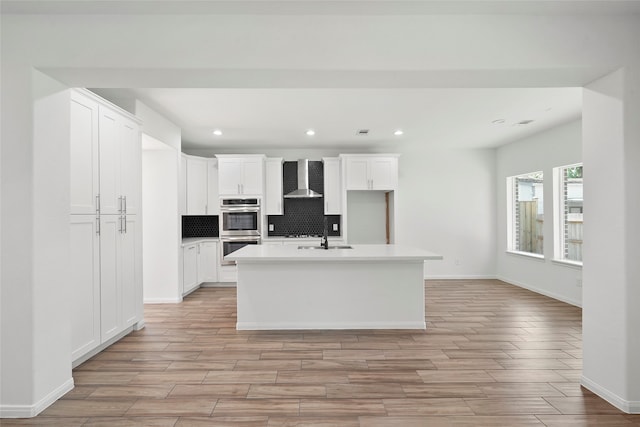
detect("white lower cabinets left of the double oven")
[182,241,220,295]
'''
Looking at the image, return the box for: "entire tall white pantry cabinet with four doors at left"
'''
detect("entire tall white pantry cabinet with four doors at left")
[70,89,142,361]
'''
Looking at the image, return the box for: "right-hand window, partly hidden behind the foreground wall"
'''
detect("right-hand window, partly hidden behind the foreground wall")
[553,163,583,264]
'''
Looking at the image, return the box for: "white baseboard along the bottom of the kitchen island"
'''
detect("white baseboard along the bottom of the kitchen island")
[236,322,427,331]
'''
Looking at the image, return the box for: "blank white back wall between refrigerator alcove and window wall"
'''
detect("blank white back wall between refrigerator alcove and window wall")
[395,147,496,279]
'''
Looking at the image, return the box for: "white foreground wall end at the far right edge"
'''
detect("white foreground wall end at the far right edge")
[582,68,640,412]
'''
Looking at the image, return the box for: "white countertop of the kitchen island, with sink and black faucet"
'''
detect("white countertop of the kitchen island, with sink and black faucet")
[226,243,442,263]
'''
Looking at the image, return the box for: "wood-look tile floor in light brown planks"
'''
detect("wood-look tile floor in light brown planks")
[7,280,640,427]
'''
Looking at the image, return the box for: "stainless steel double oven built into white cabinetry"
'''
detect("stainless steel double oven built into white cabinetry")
[220,199,262,265]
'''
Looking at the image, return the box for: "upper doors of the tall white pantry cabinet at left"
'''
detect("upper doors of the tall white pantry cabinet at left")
[70,90,141,215]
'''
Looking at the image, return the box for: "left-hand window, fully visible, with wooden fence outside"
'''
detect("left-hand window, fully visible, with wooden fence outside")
[507,171,544,255]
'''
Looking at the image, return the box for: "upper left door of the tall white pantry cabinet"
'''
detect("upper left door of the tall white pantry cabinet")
[69,91,99,215]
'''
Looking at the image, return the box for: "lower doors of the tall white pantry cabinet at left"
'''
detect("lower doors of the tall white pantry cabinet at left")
[69,215,142,361]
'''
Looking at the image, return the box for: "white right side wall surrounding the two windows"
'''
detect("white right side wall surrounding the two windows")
[496,121,589,306]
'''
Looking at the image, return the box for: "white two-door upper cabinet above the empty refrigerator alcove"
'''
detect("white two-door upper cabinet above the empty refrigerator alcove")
[341,154,398,191]
